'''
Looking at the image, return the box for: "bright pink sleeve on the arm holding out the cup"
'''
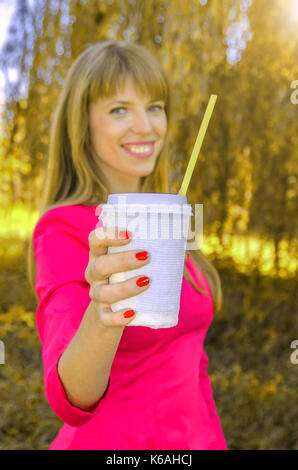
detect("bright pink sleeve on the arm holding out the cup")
[33,208,110,426]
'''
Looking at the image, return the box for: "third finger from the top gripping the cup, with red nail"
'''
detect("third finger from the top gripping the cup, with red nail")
[89,276,150,305]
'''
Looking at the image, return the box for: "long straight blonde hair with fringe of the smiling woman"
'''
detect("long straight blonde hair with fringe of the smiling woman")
[27,40,222,312]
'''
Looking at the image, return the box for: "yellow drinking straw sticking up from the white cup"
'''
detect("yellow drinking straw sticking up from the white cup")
[178,95,217,196]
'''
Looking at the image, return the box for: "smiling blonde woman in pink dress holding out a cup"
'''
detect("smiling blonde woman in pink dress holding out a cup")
[29,41,227,450]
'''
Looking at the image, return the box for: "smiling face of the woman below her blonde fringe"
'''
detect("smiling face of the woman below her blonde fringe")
[89,77,167,193]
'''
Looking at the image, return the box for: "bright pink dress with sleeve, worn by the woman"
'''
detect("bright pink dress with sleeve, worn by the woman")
[33,205,227,450]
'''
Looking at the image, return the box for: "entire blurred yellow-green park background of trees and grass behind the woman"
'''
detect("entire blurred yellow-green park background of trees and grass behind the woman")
[0,0,298,450]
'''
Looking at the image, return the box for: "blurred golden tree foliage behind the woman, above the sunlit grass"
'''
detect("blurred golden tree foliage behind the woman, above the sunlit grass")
[0,0,298,276]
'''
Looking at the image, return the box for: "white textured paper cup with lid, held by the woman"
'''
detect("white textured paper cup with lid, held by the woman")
[100,193,193,329]
